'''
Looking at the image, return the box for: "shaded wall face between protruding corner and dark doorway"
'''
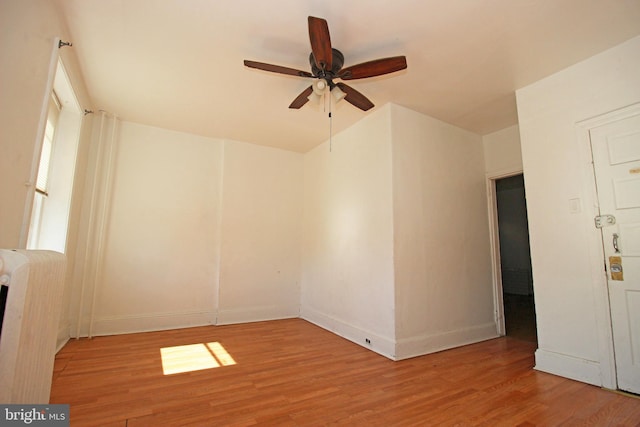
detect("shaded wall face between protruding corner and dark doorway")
[391,105,496,358]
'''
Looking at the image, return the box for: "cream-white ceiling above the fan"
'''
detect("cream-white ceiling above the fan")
[58,0,640,152]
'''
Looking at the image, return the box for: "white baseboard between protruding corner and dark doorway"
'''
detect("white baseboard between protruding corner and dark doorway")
[396,322,498,360]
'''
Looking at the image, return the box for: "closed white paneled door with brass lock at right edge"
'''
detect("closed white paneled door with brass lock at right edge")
[590,115,640,393]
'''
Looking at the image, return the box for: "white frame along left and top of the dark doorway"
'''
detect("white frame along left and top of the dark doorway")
[486,168,523,336]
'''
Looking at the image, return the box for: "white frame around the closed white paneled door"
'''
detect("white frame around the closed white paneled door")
[575,103,640,390]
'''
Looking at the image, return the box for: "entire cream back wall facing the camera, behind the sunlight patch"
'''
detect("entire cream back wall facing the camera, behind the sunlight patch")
[72,119,303,335]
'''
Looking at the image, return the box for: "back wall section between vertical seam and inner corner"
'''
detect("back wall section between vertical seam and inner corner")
[218,141,303,324]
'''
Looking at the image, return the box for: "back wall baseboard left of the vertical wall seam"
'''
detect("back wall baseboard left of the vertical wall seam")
[83,311,216,336]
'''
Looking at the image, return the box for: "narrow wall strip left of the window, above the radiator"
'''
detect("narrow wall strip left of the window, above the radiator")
[0,1,55,248]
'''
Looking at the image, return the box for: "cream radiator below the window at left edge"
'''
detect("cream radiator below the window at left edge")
[0,249,66,404]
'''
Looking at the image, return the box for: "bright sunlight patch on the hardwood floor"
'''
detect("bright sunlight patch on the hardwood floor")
[160,342,236,375]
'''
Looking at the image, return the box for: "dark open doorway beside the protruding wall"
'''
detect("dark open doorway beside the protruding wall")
[495,174,537,343]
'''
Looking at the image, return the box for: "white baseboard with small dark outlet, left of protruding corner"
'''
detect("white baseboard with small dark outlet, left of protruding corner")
[300,307,396,360]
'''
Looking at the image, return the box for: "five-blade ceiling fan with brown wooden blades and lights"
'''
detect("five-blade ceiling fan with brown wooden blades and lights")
[244,16,407,111]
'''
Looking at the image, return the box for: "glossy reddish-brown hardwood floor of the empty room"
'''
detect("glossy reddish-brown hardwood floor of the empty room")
[51,319,640,427]
